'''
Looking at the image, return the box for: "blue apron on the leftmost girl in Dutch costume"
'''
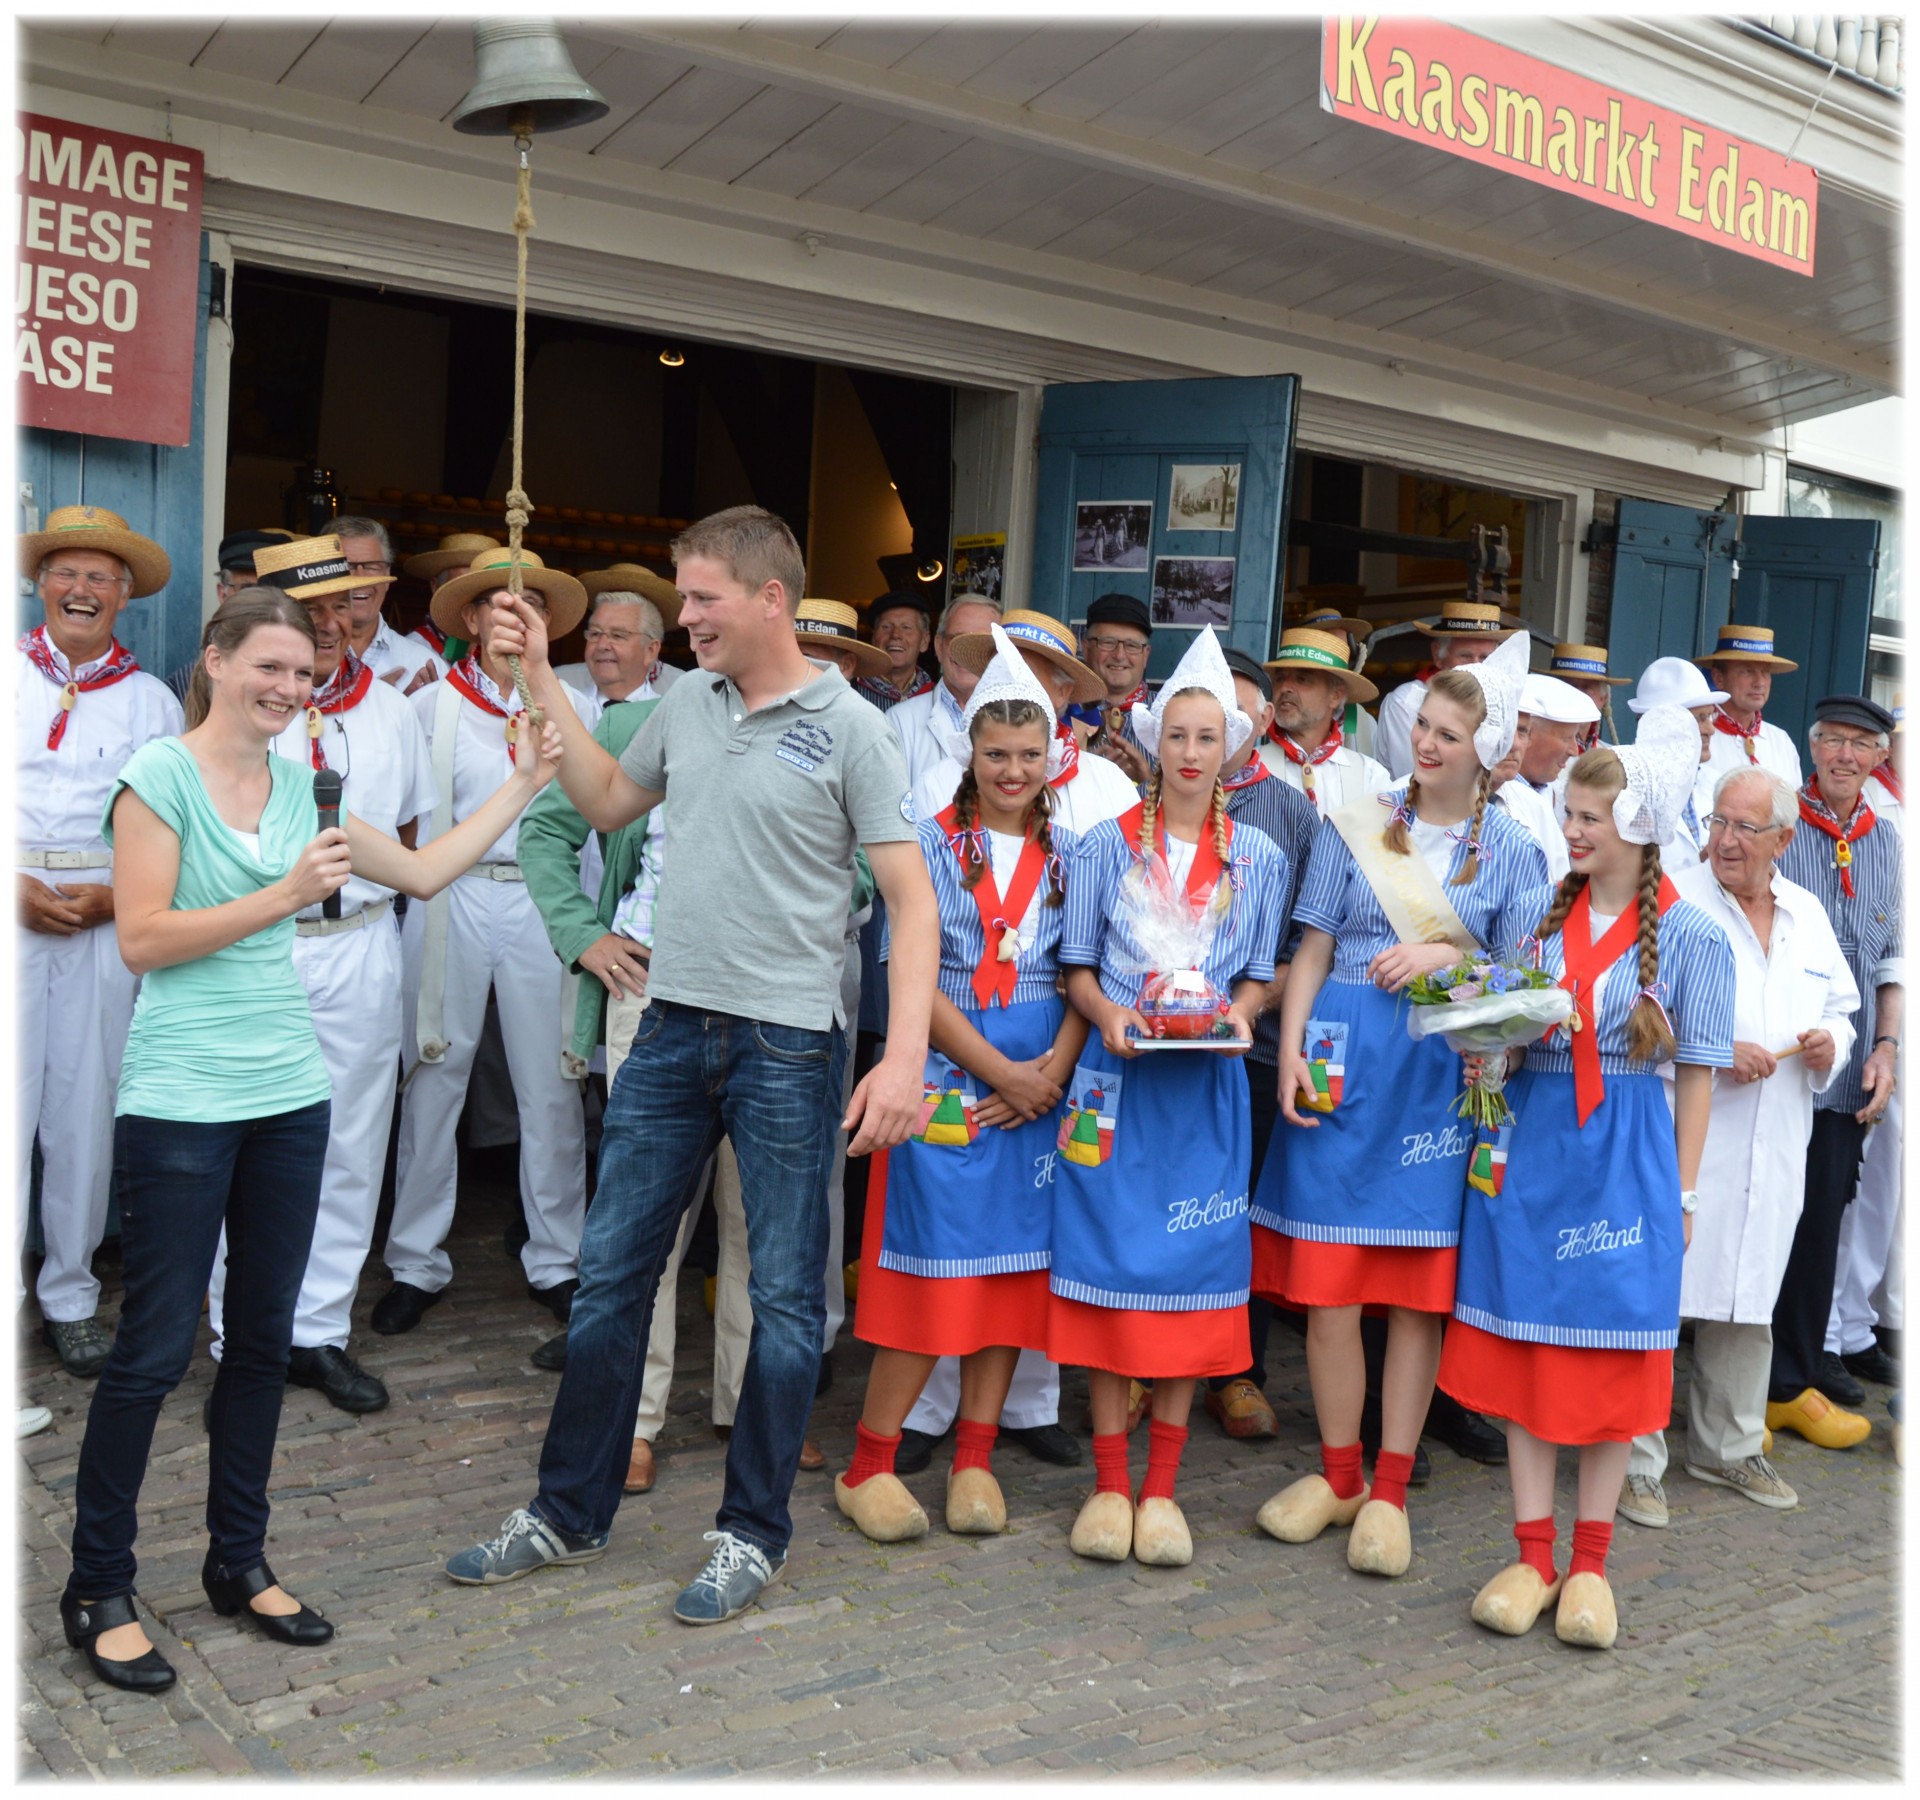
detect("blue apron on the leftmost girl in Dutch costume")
[879,998,1064,1280]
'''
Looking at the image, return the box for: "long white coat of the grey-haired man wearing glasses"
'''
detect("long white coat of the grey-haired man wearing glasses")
[1661,864,1860,1324]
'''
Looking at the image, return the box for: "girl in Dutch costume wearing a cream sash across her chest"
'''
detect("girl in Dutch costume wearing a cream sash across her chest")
[1252,631,1548,1575]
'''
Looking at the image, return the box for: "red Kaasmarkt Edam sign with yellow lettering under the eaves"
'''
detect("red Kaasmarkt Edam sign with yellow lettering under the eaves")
[1321,17,1820,274]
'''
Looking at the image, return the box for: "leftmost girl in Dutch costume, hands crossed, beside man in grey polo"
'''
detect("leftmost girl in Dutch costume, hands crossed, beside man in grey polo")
[833,626,1087,1543]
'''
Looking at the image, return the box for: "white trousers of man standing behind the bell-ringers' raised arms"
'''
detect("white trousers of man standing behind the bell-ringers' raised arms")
[386,875,588,1293]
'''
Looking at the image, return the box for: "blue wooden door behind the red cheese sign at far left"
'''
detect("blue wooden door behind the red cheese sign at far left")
[15,224,213,679]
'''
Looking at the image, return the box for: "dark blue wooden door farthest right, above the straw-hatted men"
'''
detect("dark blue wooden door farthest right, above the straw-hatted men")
[1734,518,1880,746]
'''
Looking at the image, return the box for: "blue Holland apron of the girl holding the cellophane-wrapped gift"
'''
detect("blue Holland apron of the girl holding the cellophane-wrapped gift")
[1050,1038,1254,1313]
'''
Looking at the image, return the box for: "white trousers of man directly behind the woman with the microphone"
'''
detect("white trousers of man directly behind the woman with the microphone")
[209,912,399,1359]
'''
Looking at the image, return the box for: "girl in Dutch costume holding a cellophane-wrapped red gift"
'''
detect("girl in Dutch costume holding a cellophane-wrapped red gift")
[1046,628,1286,1566]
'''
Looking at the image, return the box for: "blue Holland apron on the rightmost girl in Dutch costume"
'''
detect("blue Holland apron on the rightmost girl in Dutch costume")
[1453,1067,1686,1351]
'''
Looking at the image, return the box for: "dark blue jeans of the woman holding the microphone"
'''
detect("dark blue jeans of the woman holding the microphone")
[67,1100,332,1600]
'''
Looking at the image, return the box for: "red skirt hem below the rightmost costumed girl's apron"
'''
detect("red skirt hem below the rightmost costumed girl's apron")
[1440,1318,1674,1445]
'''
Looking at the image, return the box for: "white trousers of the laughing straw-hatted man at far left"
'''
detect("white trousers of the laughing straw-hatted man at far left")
[13,890,134,1322]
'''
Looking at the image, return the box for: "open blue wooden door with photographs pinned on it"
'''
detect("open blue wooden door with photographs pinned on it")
[1031,374,1300,679]
